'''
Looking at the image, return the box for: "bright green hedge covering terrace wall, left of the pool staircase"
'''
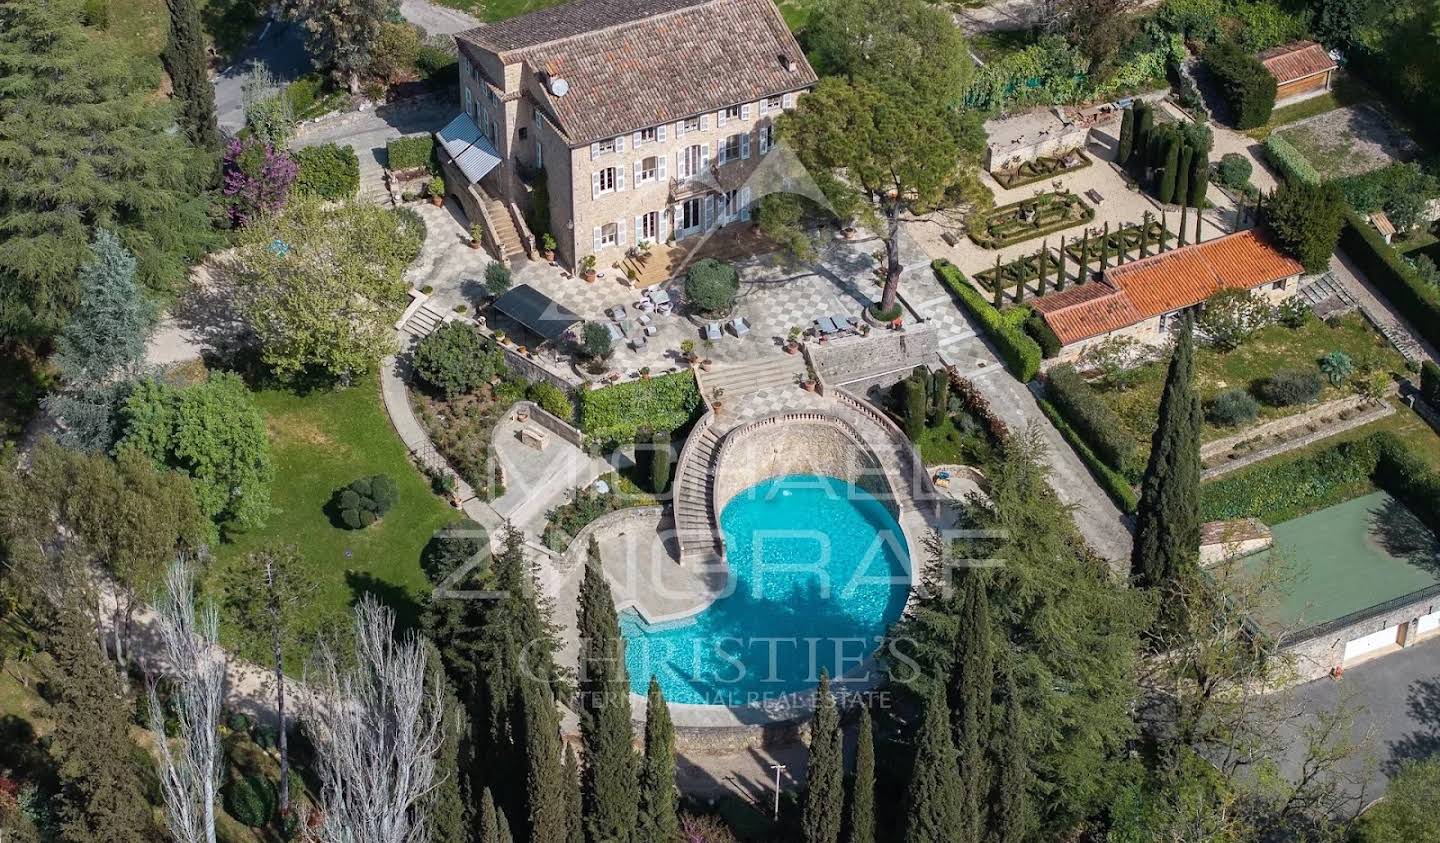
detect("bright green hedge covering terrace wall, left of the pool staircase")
[580,372,700,442]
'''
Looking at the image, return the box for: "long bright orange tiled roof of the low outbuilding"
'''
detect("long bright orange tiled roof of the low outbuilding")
[1034,229,1305,344]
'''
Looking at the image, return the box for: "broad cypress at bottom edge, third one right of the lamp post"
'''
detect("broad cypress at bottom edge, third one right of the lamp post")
[901,683,965,843]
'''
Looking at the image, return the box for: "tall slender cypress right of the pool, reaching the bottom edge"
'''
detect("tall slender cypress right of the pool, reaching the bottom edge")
[949,569,995,840]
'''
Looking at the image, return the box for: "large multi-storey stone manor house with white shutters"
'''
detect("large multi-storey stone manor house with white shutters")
[438,0,816,268]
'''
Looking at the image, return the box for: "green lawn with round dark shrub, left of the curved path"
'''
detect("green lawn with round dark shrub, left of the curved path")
[210,382,455,656]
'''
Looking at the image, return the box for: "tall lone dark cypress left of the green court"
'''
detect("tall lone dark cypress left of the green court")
[1130,317,1200,607]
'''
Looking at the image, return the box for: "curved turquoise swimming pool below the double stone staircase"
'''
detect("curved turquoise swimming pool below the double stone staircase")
[621,474,910,706]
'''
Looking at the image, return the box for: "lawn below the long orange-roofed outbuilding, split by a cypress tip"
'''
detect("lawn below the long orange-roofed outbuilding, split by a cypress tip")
[1100,314,1404,447]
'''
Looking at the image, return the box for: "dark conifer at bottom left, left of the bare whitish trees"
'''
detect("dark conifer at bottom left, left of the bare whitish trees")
[48,607,158,843]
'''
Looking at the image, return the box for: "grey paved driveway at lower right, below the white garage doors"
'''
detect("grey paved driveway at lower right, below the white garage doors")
[1283,640,1440,803]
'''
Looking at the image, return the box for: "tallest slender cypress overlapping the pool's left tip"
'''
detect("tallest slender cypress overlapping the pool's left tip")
[577,536,639,840]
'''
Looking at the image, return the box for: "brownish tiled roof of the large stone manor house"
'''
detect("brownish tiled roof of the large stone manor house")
[456,0,816,144]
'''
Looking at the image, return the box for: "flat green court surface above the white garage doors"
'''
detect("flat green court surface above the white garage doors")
[1244,491,1440,630]
